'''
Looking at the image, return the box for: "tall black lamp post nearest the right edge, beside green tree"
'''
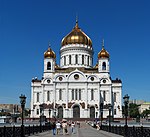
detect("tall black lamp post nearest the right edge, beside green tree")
[123,94,129,137]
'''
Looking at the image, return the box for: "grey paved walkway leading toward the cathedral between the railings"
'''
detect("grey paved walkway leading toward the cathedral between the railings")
[28,123,122,137]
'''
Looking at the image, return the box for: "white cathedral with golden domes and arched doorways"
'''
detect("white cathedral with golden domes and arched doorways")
[31,21,122,118]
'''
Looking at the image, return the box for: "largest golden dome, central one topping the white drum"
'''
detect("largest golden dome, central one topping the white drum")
[61,21,92,46]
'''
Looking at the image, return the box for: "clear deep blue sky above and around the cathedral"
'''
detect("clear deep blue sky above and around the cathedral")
[0,0,150,107]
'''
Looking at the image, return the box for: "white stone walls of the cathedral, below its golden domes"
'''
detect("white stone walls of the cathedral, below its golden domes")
[31,44,122,118]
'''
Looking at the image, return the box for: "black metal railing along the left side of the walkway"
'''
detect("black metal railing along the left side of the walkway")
[0,125,51,137]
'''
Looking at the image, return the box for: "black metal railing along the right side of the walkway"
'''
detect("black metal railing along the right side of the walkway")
[102,125,150,137]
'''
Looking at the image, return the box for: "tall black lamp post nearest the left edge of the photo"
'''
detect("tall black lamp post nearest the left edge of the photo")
[19,94,26,137]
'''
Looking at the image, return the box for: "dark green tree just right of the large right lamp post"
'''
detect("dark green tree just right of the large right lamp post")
[129,103,140,118]
